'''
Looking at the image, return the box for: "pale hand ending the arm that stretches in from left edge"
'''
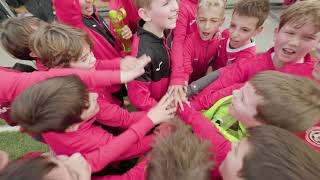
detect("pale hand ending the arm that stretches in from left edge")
[120,55,151,83]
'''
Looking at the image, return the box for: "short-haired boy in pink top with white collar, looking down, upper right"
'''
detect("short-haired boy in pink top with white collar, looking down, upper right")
[213,0,269,70]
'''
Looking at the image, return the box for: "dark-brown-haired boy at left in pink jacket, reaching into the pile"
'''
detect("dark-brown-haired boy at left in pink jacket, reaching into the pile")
[11,76,176,172]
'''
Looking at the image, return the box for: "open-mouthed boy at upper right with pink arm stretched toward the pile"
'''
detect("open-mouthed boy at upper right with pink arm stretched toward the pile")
[191,1,320,110]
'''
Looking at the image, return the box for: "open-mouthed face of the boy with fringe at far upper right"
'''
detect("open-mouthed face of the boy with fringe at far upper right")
[274,22,319,64]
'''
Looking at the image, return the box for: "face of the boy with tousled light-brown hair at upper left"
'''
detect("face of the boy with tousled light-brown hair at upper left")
[70,44,96,70]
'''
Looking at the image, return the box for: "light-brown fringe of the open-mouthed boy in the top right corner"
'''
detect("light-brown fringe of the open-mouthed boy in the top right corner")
[279,0,320,33]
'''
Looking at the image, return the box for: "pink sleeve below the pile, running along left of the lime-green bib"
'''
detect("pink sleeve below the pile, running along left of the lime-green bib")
[178,107,231,167]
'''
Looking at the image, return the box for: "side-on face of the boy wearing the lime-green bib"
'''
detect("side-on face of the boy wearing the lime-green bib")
[229,82,263,128]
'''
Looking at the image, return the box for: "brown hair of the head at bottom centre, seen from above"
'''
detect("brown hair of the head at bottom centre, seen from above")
[147,119,213,180]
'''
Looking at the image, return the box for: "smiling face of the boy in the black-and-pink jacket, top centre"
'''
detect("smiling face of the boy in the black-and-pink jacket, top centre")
[146,0,179,29]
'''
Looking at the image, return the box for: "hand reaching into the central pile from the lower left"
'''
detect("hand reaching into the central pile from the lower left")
[147,94,177,125]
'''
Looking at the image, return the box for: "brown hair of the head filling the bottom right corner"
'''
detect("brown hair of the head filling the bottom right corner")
[240,126,320,180]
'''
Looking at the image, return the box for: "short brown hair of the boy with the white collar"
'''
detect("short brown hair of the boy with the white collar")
[233,0,270,27]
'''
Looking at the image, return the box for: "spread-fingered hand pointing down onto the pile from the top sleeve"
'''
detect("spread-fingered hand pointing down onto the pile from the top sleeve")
[168,82,190,110]
